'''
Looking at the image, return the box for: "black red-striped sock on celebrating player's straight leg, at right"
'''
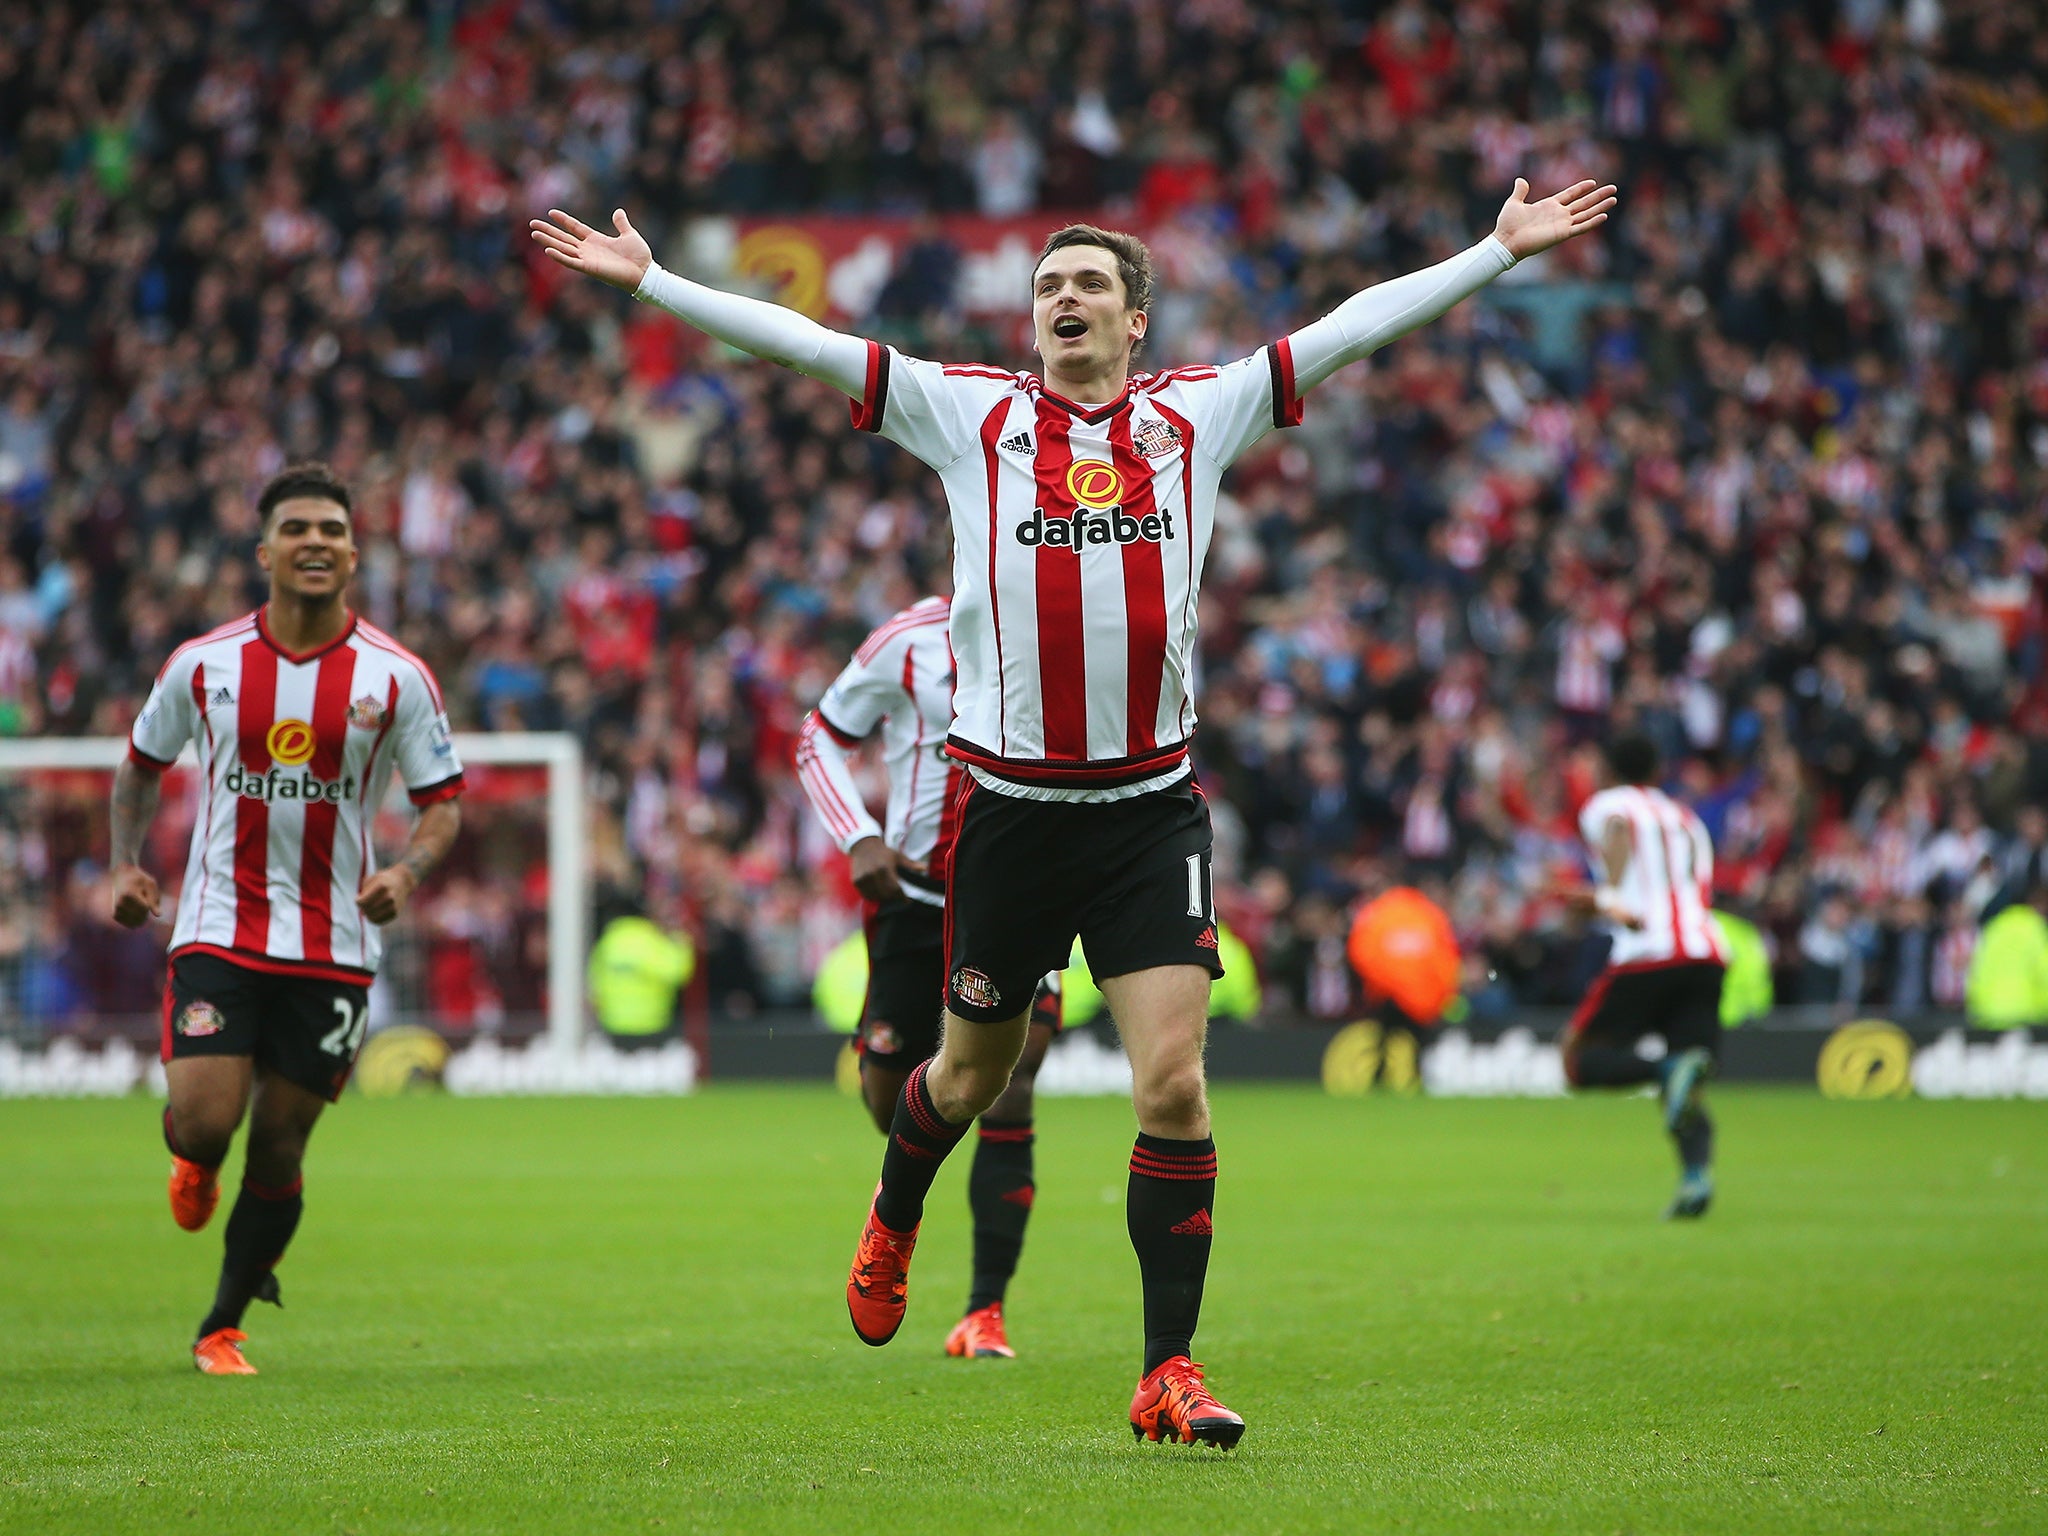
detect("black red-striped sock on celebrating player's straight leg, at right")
[1124,1130,1217,1374]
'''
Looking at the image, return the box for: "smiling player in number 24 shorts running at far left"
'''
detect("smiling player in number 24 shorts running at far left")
[113,465,463,1376]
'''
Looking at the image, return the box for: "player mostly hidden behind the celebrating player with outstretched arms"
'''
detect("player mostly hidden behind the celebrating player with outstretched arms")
[797,598,1059,1360]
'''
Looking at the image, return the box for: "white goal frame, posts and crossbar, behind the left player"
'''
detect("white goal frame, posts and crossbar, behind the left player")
[0,731,590,1057]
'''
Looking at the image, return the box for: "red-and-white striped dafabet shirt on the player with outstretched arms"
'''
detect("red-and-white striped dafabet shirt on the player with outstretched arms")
[854,340,1300,799]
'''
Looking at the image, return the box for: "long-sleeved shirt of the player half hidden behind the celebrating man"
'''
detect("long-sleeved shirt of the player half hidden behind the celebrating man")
[797,598,961,907]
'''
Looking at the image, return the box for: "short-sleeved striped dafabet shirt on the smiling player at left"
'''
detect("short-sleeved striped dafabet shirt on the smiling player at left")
[129,610,463,981]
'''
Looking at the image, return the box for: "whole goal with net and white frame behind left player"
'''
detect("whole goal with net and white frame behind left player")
[0,731,590,1092]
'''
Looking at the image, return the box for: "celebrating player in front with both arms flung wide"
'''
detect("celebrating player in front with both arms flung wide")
[532,182,1614,1446]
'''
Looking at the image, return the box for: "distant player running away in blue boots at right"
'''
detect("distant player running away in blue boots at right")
[1563,735,1729,1219]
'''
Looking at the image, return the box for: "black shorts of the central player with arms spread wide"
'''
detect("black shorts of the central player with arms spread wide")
[946,778,1223,1024]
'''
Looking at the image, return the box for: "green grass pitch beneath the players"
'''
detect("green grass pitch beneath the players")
[0,1087,2048,1536]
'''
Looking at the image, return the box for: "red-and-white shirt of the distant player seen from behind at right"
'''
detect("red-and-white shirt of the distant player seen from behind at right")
[1579,784,1729,971]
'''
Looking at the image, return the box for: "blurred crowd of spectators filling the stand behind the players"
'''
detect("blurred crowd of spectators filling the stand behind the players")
[0,0,2048,1024]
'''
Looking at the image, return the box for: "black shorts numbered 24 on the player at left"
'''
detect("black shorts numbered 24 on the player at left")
[162,954,371,1104]
